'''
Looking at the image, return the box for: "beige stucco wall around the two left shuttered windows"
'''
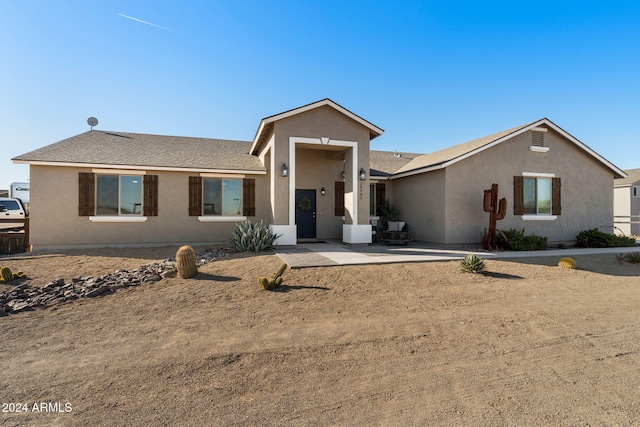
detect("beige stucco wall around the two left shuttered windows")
[30,165,272,248]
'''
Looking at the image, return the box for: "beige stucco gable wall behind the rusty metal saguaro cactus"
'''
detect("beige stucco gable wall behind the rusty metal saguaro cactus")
[442,130,613,244]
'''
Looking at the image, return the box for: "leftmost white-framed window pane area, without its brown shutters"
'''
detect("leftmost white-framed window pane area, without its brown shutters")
[95,174,143,216]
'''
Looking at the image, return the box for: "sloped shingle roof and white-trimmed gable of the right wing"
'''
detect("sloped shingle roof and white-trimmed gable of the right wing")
[394,118,626,178]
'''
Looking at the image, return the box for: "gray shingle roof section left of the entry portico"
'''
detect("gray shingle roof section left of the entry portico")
[13,130,266,172]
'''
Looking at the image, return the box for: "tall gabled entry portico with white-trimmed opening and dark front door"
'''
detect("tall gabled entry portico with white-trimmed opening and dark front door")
[250,99,383,245]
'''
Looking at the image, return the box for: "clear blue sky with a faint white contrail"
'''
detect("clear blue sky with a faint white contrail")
[0,0,640,188]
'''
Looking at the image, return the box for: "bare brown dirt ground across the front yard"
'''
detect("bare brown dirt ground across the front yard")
[0,248,640,427]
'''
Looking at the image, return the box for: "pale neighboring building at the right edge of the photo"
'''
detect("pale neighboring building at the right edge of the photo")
[613,169,640,236]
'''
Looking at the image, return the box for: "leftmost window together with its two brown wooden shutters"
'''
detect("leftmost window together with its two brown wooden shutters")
[78,172,158,218]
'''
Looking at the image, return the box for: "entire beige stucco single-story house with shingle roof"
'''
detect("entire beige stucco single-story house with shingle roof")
[13,99,626,248]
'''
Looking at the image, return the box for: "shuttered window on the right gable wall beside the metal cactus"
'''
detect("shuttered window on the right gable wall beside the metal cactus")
[513,173,562,219]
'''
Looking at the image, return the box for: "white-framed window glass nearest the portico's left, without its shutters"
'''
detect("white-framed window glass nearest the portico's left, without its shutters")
[202,178,242,216]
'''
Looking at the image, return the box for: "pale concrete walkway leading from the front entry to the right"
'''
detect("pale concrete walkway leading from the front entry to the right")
[276,242,640,268]
